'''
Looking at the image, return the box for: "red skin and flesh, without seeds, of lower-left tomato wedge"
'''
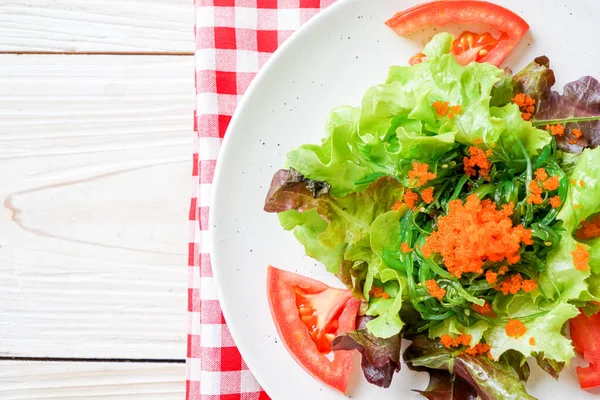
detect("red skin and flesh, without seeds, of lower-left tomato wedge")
[267,266,360,393]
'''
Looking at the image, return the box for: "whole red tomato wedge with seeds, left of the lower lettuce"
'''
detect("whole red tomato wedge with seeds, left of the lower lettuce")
[267,266,360,393]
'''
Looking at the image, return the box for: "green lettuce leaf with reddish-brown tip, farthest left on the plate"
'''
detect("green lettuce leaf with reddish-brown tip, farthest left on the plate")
[265,170,404,273]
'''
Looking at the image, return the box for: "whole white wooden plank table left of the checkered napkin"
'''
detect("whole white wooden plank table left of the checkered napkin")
[0,0,194,400]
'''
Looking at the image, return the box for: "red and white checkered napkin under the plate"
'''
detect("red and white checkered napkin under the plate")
[186,0,335,400]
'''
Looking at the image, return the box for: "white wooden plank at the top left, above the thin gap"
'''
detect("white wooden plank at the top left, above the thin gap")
[0,0,194,53]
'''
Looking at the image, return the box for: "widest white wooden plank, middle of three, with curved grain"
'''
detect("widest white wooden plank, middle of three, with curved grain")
[0,55,194,359]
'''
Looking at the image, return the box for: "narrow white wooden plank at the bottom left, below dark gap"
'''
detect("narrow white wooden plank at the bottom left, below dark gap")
[0,361,185,400]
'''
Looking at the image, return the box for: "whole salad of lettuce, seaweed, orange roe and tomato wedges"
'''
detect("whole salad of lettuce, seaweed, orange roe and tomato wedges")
[264,1,600,400]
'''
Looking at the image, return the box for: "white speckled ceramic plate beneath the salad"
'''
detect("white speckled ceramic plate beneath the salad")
[211,0,600,400]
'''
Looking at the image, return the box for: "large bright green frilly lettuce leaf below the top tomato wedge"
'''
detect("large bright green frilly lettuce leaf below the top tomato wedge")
[287,33,551,197]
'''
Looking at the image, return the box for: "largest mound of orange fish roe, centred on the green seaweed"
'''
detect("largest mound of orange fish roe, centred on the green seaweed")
[422,194,533,278]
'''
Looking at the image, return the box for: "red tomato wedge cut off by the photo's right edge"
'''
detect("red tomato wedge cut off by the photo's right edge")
[569,313,600,389]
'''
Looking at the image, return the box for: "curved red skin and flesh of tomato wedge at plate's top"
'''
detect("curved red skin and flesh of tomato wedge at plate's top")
[386,0,529,66]
